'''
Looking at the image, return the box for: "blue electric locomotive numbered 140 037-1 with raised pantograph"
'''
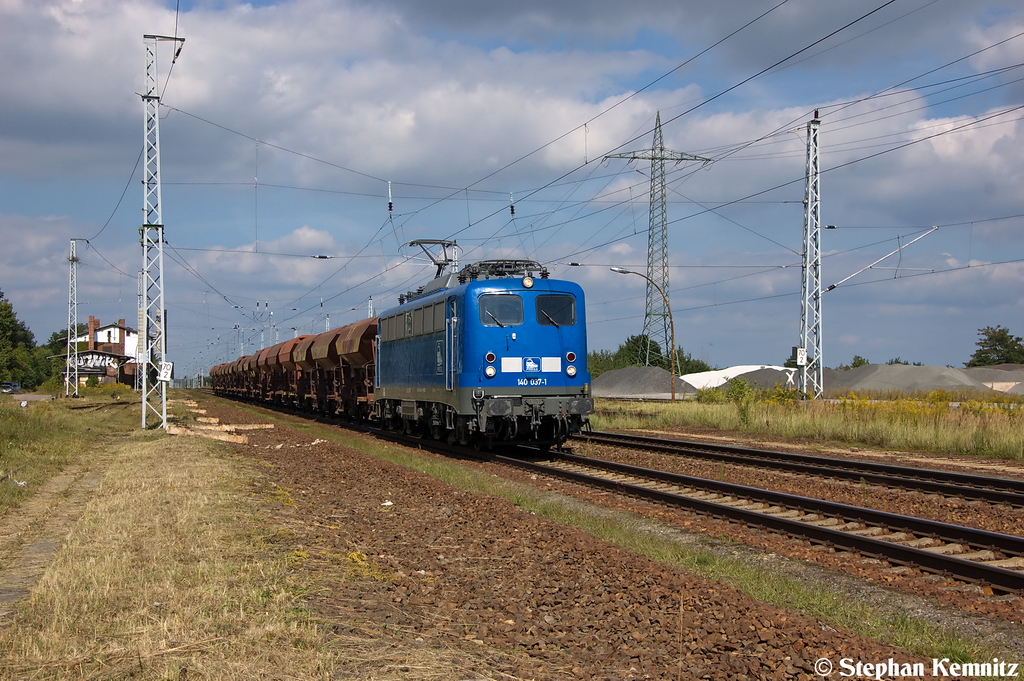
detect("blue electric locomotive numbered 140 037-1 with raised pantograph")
[374,242,594,448]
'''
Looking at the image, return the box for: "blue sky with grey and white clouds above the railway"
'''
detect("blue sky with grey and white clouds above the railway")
[0,0,1024,376]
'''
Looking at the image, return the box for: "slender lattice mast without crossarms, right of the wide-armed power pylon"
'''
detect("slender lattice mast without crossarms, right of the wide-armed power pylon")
[797,112,824,399]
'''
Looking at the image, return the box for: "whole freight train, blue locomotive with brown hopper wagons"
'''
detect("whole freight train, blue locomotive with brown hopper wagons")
[210,241,594,449]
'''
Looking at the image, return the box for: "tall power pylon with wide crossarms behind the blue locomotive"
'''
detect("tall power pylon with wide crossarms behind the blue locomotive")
[605,112,711,367]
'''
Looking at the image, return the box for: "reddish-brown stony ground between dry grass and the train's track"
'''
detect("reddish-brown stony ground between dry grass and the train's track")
[190,405,1015,679]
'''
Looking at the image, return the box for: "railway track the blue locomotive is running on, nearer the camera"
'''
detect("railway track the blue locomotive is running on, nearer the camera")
[495,455,1024,594]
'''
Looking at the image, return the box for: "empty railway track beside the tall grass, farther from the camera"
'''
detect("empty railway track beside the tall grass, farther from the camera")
[573,432,1024,508]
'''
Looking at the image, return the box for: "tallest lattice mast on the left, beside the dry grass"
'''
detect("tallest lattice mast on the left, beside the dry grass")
[138,35,184,430]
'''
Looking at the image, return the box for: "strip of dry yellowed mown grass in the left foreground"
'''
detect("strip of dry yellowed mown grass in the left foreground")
[0,436,337,679]
